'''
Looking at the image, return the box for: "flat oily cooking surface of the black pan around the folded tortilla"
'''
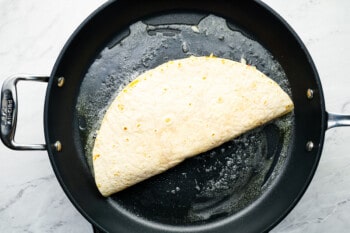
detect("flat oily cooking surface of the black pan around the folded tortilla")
[76,13,294,225]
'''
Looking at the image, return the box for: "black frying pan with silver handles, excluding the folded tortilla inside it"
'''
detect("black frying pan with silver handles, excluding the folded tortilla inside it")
[1,0,345,232]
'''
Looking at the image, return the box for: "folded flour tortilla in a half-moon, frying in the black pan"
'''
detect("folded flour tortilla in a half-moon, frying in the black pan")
[93,56,294,196]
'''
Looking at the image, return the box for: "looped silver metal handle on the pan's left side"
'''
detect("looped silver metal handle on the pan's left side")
[0,76,49,150]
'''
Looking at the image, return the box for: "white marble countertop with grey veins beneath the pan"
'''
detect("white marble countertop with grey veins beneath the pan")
[0,0,350,233]
